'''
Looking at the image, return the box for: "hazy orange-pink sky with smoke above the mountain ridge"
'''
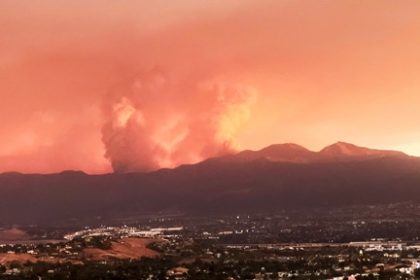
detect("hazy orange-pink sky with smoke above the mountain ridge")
[0,0,420,173]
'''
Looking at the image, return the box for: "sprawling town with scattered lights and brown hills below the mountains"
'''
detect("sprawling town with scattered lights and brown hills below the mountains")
[0,203,420,280]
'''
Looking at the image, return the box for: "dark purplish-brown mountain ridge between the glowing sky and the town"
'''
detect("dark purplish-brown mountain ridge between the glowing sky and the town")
[0,141,420,226]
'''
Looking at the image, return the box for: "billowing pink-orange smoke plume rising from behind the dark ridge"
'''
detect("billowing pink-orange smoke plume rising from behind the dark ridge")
[102,71,256,172]
